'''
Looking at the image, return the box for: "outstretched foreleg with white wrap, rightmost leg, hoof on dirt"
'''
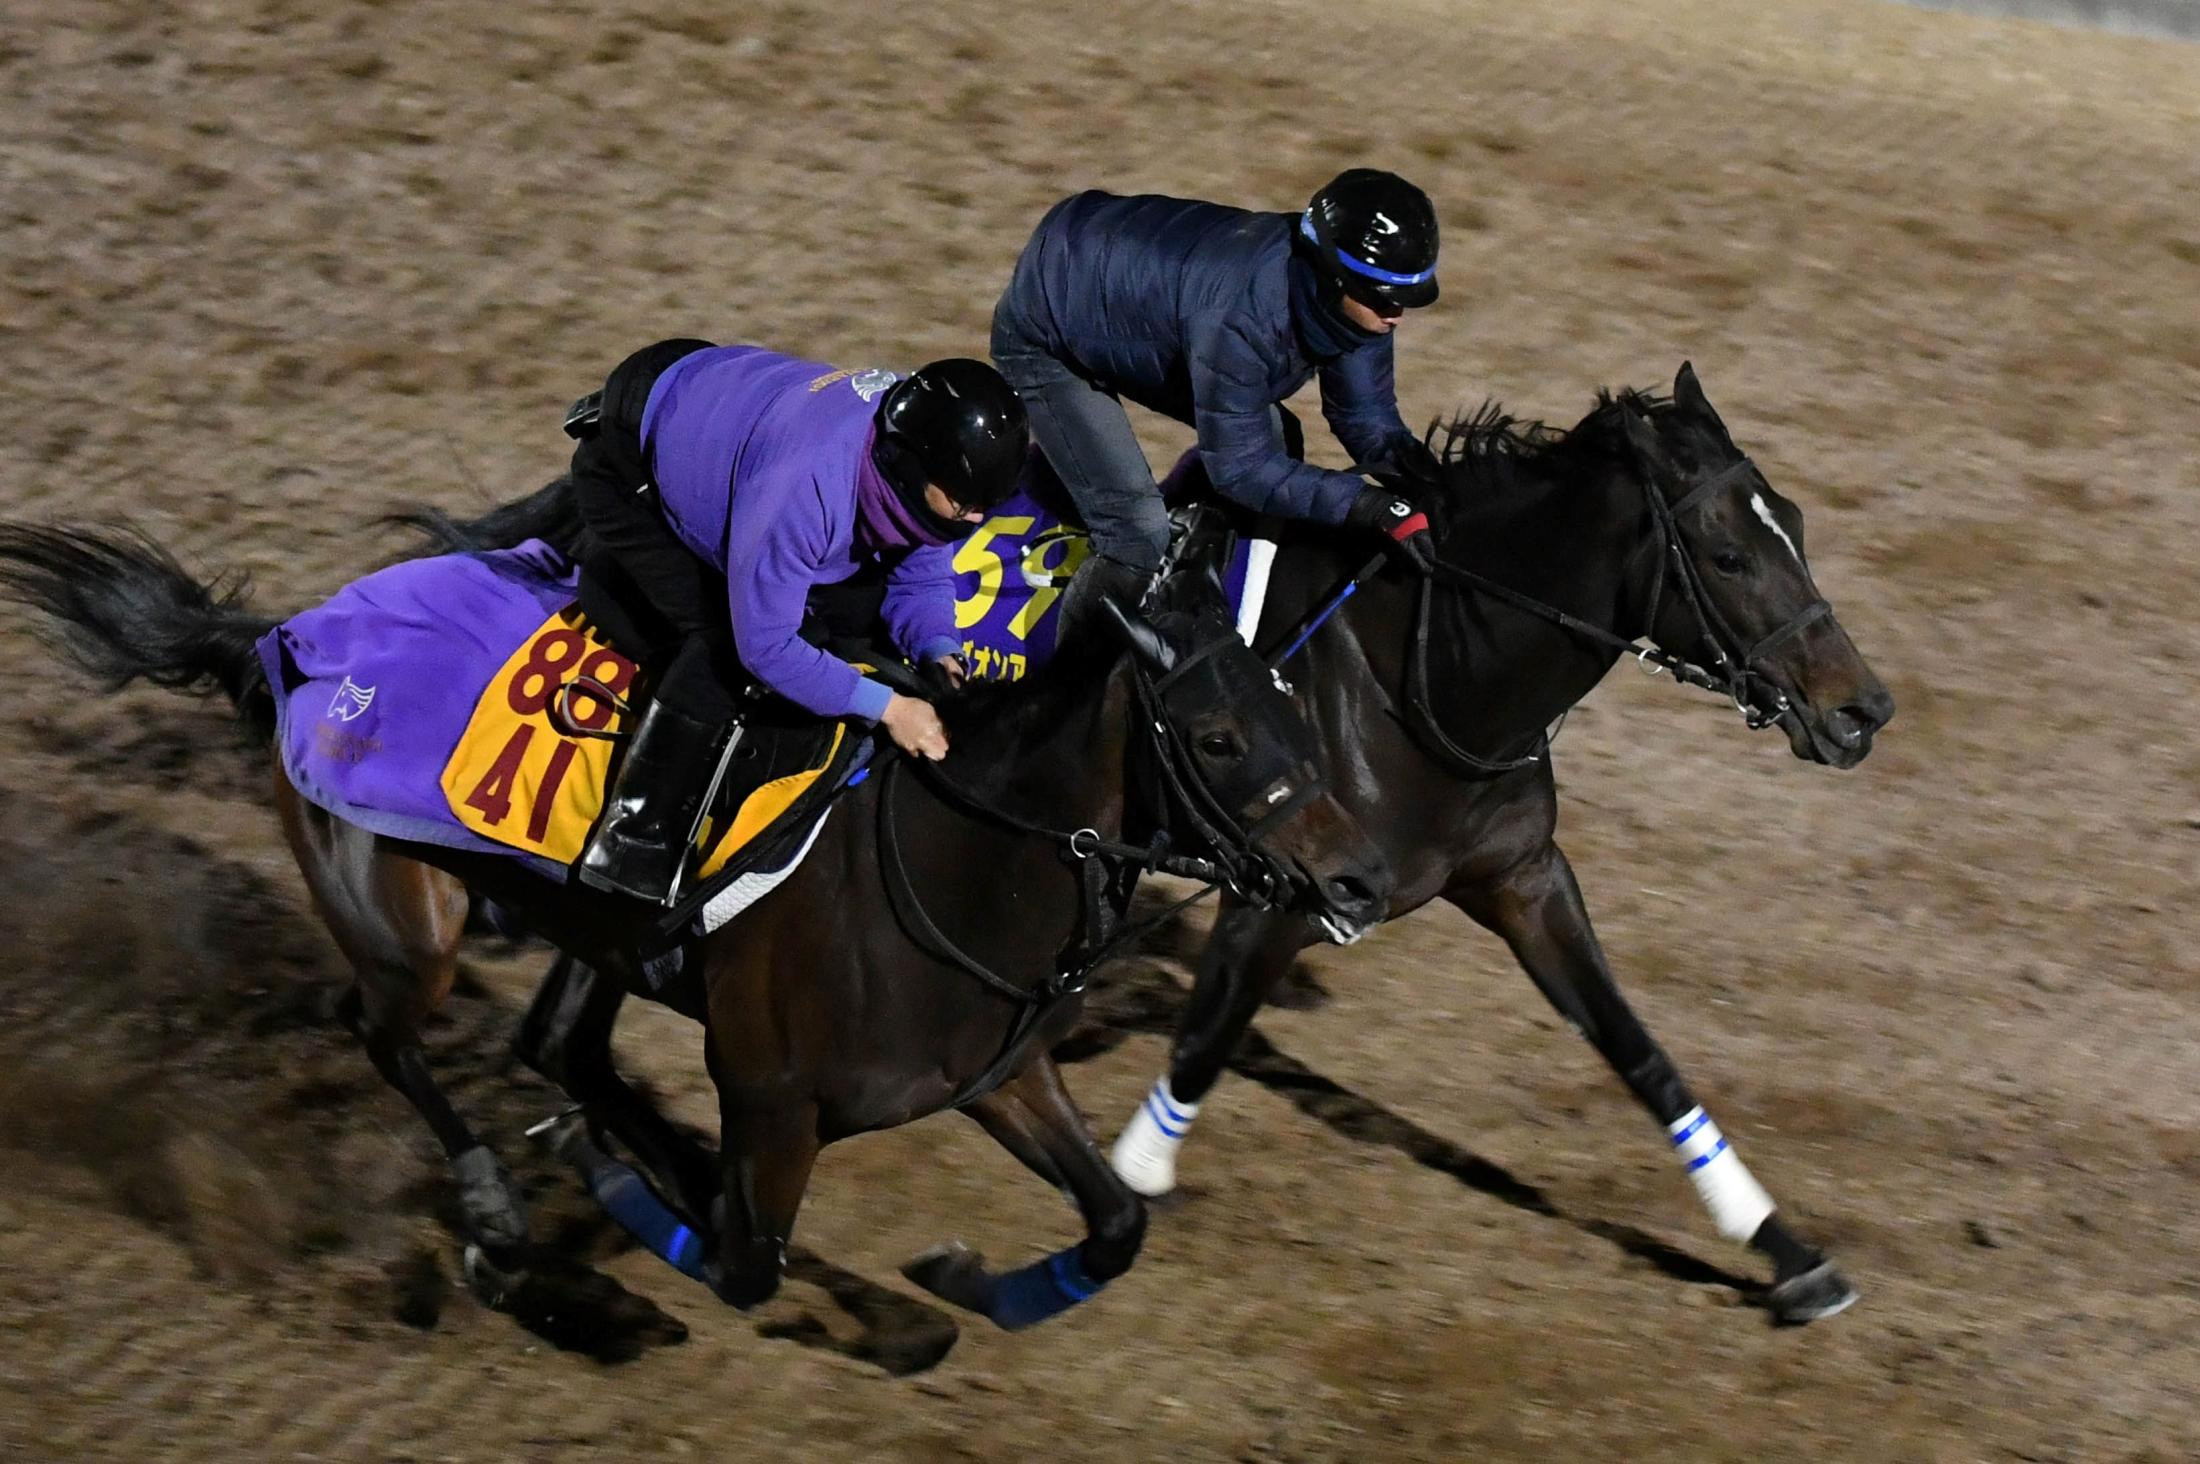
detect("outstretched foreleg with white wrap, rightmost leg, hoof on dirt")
[1445,843,1857,1323]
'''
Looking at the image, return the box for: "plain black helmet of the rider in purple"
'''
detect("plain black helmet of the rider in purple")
[878,357,1032,509]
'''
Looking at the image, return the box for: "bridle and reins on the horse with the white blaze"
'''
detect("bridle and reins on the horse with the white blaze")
[1269,442,1833,773]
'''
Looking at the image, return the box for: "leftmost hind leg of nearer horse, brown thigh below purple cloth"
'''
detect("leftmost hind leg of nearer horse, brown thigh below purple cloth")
[275,773,528,1257]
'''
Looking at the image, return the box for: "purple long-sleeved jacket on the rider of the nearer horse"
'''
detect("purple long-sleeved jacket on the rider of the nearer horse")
[642,346,961,722]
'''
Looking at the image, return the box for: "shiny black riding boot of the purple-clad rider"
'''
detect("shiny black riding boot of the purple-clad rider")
[576,700,726,905]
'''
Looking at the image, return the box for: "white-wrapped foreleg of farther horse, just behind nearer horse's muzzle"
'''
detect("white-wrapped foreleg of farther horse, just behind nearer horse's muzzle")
[1109,905,1313,1200]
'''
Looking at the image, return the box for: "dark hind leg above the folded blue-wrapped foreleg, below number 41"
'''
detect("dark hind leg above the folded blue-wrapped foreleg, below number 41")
[513,953,717,1215]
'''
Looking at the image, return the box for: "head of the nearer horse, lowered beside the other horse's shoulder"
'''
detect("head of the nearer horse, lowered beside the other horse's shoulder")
[1096,572,1395,942]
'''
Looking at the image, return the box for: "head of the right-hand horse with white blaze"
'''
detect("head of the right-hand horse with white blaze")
[1624,363,1894,768]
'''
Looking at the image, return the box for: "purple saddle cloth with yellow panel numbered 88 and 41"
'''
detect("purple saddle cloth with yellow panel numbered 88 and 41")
[260,542,862,885]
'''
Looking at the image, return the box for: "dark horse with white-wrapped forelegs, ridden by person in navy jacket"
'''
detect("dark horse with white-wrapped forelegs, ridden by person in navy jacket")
[1113,365,1894,1321]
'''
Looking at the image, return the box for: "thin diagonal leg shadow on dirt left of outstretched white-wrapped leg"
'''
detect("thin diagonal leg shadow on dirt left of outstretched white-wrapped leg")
[1054,936,1767,1305]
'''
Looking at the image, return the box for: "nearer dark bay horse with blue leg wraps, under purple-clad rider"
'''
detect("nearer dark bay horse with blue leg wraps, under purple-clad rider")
[0,524,1390,1325]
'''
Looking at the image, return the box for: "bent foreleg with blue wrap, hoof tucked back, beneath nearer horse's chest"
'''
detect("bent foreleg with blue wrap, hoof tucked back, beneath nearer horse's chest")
[902,1057,1146,1332]
